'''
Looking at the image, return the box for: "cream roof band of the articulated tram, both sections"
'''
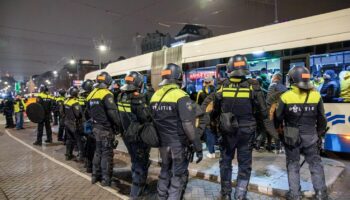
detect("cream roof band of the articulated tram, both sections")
[85,8,350,79]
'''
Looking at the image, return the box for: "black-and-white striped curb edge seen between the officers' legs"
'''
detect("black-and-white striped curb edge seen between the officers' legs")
[114,149,345,197]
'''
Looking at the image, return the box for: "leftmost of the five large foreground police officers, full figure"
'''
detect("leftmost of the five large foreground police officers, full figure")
[87,72,120,186]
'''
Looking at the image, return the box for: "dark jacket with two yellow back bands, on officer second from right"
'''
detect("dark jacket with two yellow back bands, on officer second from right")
[213,78,270,127]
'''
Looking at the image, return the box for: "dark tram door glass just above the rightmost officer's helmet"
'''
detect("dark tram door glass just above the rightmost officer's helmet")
[281,54,310,83]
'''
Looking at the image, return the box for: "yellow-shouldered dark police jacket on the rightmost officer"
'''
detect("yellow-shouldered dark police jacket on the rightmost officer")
[276,86,327,147]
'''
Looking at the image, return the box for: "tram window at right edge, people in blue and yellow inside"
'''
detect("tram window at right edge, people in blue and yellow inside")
[310,51,350,103]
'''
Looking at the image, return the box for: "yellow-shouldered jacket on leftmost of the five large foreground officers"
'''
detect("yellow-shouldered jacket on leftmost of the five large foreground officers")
[87,87,120,131]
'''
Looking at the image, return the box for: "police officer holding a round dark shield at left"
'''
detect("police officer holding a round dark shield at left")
[33,85,54,145]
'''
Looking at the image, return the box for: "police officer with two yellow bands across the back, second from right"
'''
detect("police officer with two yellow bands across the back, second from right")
[213,55,277,199]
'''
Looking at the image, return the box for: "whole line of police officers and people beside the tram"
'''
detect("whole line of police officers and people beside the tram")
[0,55,328,200]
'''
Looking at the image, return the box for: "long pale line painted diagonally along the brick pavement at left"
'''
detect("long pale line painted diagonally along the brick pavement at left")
[5,130,129,200]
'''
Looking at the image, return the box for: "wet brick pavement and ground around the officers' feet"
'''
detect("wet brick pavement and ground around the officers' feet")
[0,118,350,200]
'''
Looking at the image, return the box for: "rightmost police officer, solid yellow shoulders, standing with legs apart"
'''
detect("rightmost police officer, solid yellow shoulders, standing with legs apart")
[276,66,328,200]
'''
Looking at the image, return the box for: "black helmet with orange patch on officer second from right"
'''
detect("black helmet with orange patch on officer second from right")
[226,54,250,77]
